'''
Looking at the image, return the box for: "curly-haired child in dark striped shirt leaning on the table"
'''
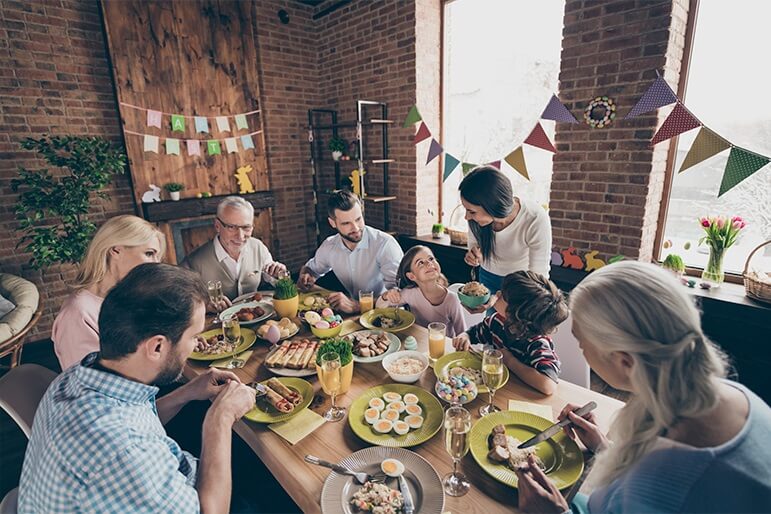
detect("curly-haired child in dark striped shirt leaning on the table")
[453,271,568,394]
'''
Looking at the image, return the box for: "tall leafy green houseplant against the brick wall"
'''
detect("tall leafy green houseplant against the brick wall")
[11,136,127,269]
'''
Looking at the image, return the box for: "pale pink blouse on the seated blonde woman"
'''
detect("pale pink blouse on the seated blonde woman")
[51,289,104,371]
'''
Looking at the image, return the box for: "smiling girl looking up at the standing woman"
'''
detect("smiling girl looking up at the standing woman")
[377,246,466,337]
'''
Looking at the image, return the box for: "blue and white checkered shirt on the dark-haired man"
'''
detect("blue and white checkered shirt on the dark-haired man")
[18,353,200,513]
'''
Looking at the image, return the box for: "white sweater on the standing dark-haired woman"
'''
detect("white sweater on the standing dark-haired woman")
[468,199,551,278]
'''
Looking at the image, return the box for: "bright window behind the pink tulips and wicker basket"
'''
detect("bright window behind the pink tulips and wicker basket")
[660,0,771,273]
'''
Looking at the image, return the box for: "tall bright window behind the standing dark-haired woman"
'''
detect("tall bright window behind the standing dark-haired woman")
[442,0,565,223]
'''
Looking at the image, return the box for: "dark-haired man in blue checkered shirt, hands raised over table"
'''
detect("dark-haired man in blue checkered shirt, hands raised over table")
[18,264,255,513]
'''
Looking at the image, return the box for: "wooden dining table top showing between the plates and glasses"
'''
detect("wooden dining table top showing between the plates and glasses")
[184,312,623,514]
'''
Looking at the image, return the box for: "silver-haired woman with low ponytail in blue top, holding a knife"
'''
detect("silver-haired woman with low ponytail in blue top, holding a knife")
[518,262,771,514]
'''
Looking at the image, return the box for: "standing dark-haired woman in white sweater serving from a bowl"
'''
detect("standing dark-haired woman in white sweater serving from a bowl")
[459,166,551,302]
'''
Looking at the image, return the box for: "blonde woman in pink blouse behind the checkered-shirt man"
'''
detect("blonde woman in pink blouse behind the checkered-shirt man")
[51,215,166,370]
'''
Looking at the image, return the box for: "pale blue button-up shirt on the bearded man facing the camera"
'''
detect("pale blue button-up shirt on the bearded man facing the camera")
[305,226,404,300]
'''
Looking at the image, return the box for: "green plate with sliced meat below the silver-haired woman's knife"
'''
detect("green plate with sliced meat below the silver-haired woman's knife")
[469,411,584,489]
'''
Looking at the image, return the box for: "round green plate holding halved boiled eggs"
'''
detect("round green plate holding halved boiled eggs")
[348,384,444,448]
